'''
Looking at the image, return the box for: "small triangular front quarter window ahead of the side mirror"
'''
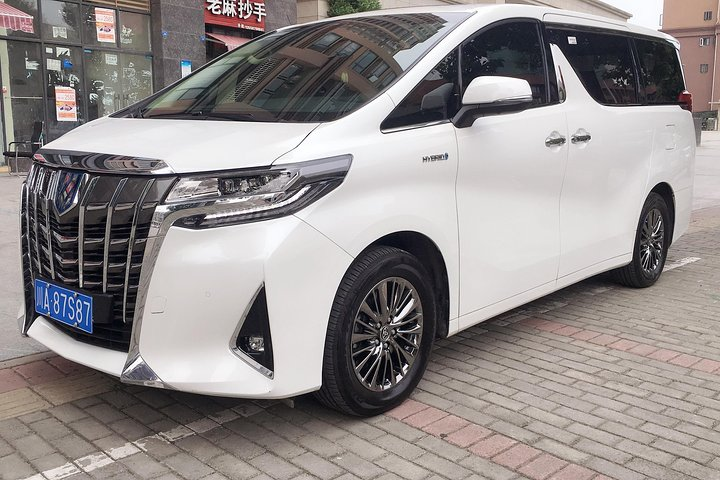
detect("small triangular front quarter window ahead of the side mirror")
[380,50,460,129]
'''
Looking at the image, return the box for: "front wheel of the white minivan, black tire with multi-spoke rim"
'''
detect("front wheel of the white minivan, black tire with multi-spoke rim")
[315,246,437,416]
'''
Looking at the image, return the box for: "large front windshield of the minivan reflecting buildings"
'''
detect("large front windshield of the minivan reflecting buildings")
[132,13,470,122]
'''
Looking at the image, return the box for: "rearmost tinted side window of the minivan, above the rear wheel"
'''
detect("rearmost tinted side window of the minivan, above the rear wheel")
[635,39,685,105]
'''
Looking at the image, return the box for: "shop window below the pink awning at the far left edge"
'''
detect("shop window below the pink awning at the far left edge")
[0,40,45,143]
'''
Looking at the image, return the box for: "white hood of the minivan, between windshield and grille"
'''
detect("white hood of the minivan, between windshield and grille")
[42,117,319,173]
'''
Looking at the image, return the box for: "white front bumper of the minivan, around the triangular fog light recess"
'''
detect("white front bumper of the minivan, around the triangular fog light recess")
[27,216,352,398]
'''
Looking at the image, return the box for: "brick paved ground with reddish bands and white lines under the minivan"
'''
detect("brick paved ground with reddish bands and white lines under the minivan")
[0,203,720,480]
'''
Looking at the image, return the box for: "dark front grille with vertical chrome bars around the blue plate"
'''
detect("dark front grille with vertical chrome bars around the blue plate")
[21,163,174,351]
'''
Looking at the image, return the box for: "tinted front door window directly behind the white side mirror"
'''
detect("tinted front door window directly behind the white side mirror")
[461,22,547,105]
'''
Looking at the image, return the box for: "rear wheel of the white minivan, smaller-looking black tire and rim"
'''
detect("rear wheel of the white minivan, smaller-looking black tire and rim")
[613,192,673,288]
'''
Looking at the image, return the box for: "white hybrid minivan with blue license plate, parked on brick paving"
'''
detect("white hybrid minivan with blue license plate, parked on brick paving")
[19,5,695,415]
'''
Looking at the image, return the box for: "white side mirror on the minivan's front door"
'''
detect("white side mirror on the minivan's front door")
[453,77,533,128]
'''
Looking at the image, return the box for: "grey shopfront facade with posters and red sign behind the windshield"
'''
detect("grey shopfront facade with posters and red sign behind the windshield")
[0,0,297,151]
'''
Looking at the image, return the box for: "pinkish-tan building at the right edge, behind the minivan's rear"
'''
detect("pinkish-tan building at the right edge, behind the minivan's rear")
[662,0,720,112]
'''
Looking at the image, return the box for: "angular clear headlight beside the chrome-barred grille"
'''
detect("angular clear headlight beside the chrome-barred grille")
[165,155,352,229]
